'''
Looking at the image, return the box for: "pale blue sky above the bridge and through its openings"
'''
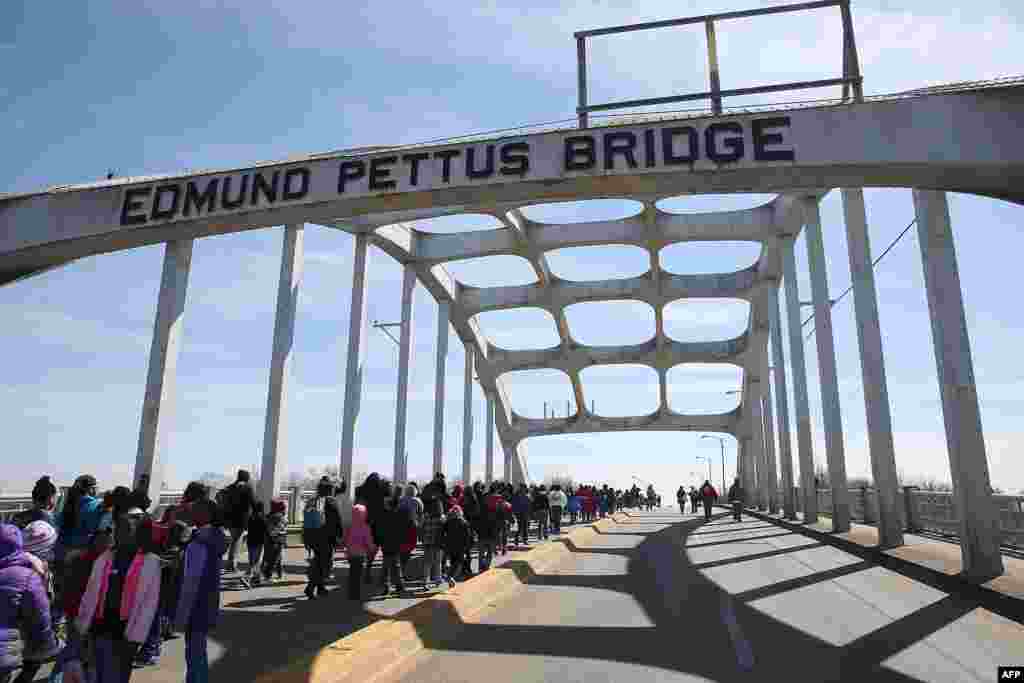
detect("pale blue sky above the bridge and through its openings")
[0,0,1024,492]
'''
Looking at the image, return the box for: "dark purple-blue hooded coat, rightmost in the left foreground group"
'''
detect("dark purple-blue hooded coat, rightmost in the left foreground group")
[174,525,227,633]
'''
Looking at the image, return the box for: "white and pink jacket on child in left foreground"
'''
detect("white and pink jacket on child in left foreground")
[75,550,160,643]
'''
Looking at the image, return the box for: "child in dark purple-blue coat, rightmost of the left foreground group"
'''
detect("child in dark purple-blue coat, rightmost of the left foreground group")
[174,501,227,683]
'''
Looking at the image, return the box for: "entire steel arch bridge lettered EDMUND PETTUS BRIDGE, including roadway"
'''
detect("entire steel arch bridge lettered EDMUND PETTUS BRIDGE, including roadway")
[0,0,1024,682]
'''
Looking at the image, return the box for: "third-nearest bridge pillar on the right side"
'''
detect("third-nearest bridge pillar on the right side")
[804,200,850,531]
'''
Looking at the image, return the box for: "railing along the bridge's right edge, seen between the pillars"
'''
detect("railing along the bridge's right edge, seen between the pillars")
[778,486,1024,548]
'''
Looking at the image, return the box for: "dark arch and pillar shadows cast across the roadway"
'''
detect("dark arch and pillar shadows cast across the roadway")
[203,513,1024,683]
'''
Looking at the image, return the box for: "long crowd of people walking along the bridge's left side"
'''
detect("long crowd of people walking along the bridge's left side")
[0,470,660,683]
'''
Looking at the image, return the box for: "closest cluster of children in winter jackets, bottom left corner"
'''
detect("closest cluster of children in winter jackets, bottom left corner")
[0,474,227,683]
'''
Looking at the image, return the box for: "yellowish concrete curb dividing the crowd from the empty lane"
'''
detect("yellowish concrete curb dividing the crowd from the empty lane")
[256,513,625,683]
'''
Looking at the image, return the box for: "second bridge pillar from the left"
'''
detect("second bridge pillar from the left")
[259,224,303,508]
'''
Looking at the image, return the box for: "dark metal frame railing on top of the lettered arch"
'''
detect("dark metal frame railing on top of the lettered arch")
[573,0,864,128]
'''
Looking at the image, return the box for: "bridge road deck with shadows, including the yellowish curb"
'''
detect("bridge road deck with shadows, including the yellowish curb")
[58,508,1024,683]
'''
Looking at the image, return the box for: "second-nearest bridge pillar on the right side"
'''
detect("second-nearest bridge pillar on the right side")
[841,187,903,548]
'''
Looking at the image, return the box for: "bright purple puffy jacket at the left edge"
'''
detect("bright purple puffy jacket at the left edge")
[0,524,60,672]
